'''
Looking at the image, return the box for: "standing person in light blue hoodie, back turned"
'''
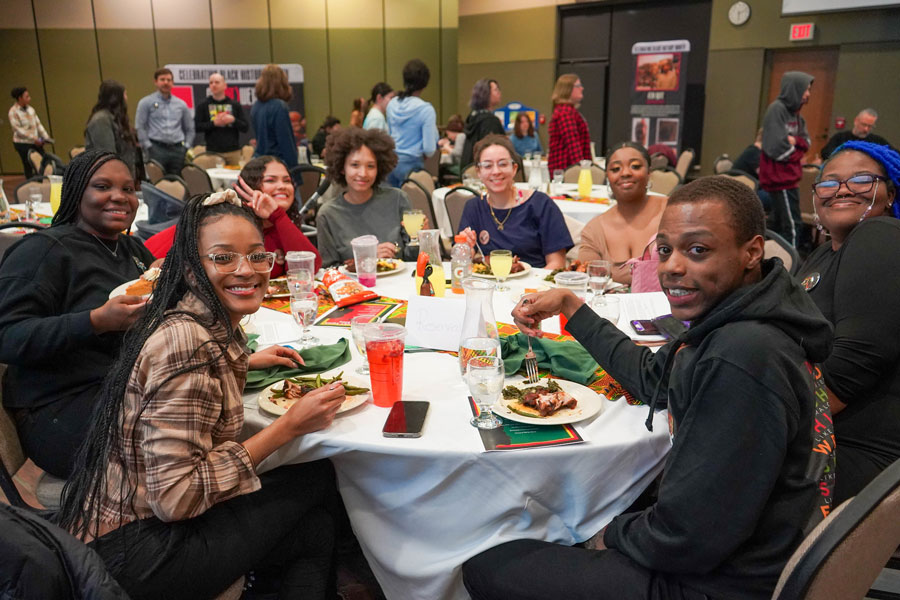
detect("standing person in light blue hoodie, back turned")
[387,58,437,187]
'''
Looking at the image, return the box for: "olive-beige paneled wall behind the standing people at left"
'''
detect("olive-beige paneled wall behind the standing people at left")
[0,0,458,173]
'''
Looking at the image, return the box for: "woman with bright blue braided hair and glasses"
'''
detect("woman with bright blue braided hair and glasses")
[800,141,900,506]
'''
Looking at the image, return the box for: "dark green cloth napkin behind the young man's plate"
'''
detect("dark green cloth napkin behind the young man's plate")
[500,333,600,385]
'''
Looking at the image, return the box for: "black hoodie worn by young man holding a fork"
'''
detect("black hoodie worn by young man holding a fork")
[566,259,832,600]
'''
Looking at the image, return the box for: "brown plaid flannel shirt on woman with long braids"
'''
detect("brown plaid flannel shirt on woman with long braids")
[93,293,260,531]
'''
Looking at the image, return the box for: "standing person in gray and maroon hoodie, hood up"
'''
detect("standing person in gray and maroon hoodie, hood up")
[759,71,813,247]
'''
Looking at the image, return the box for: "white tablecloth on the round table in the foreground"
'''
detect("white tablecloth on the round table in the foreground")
[244,264,670,600]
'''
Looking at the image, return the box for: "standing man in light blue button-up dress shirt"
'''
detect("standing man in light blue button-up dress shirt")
[134,67,194,175]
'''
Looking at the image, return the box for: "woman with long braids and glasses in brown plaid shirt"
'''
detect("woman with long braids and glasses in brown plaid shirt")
[58,190,345,598]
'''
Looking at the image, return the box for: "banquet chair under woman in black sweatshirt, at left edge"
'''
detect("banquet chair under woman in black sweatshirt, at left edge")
[0,364,65,510]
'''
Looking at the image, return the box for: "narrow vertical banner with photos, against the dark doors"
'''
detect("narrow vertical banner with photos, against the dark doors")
[631,40,691,154]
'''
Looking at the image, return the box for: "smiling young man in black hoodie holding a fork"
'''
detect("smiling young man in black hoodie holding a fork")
[463,177,832,600]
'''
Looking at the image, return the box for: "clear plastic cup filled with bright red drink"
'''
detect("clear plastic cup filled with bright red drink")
[365,323,406,407]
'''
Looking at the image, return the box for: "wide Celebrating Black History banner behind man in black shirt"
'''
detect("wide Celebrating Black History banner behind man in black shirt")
[166,64,305,145]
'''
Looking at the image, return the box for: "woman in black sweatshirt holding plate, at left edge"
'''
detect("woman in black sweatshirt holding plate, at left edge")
[0,150,153,477]
